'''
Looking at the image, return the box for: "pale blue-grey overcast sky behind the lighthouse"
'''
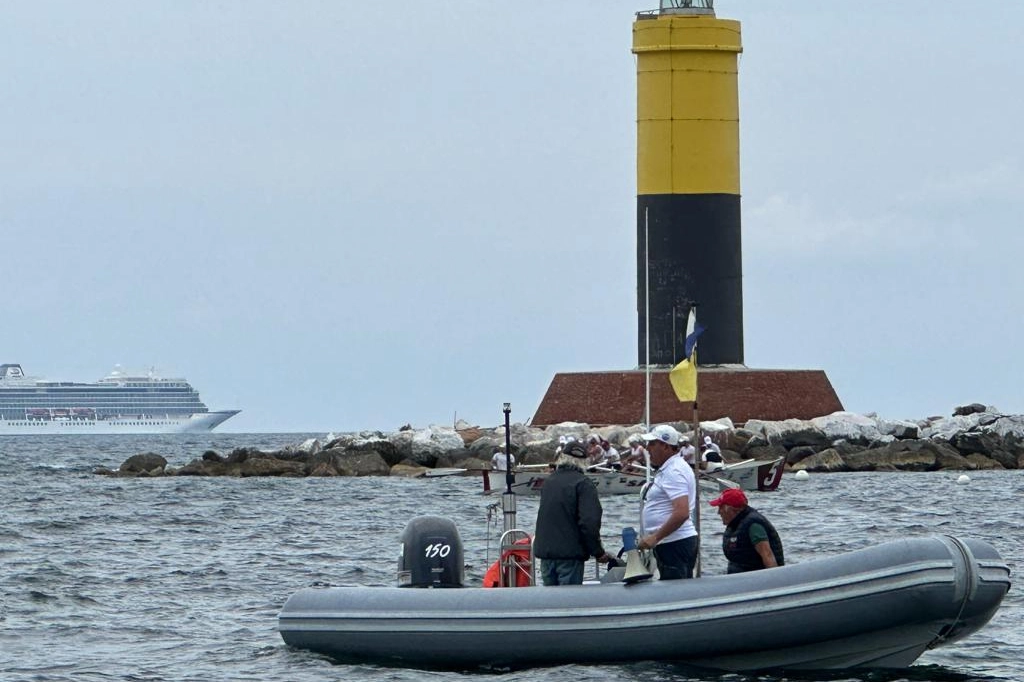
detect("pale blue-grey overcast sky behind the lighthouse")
[0,0,1024,433]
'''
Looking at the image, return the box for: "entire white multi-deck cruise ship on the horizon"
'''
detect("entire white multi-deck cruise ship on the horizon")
[0,365,240,435]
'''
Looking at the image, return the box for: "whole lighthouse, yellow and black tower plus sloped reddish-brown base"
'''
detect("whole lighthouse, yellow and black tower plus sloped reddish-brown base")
[532,0,843,426]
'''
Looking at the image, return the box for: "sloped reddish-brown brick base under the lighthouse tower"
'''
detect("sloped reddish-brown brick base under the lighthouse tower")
[530,367,843,426]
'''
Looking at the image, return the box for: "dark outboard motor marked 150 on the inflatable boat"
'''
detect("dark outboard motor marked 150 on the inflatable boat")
[398,516,465,588]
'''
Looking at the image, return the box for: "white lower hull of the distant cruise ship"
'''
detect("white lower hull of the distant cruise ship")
[0,410,240,435]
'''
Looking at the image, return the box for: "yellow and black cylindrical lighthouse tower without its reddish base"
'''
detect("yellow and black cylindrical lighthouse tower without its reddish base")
[633,0,743,366]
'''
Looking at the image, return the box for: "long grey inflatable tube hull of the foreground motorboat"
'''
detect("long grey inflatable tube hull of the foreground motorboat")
[279,536,1010,671]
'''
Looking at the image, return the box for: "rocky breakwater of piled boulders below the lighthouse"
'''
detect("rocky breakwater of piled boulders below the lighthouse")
[95,403,1024,476]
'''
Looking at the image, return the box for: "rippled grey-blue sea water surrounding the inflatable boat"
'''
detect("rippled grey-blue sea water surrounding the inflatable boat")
[0,434,1024,682]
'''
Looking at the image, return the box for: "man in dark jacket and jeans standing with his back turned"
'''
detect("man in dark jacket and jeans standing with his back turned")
[534,441,611,585]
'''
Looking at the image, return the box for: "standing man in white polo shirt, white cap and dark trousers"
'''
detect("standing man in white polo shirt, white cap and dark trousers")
[637,424,697,581]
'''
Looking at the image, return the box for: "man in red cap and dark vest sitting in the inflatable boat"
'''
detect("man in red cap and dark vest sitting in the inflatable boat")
[711,487,785,573]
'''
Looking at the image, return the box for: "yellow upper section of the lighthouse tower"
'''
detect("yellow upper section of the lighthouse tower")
[633,13,742,195]
